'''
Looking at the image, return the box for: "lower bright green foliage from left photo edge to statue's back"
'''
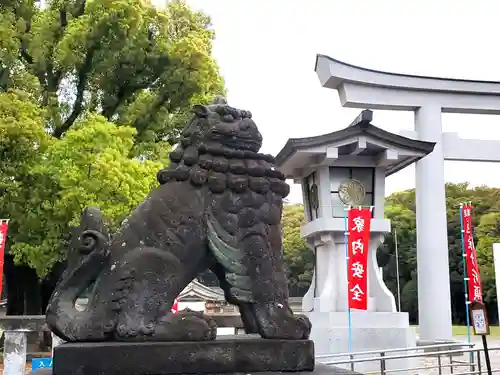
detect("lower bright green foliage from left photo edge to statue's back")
[0,93,162,276]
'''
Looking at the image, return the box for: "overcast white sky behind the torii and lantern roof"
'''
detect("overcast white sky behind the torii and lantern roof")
[155,0,500,201]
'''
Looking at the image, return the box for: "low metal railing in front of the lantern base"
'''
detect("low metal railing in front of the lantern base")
[316,343,500,375]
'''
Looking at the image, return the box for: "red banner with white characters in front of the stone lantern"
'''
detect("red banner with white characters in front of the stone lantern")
[347,208,372,310]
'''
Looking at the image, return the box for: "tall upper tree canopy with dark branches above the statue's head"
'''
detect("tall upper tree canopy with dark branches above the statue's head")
[0,0,224,145]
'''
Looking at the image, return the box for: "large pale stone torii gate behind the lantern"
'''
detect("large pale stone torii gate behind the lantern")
[315,55,500,341]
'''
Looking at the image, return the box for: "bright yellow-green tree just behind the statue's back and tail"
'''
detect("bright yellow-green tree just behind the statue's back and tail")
[5,115,162,276]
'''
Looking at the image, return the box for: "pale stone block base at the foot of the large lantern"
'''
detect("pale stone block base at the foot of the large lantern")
[306,311,416,374]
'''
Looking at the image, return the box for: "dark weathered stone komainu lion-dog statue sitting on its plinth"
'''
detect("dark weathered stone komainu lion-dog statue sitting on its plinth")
[47,99,311,341]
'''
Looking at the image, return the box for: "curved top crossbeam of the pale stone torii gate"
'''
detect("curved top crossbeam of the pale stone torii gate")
[315,55,500,114]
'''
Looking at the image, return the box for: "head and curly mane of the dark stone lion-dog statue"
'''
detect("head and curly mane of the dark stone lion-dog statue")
[157,103,290,198]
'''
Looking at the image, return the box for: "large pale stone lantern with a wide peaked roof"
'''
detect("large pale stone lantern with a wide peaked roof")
[276,110,435,371]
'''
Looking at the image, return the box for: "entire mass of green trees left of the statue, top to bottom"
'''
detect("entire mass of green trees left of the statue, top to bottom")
[0,0,225,313]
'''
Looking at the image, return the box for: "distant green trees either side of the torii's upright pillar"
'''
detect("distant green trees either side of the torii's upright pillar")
[378,183,500,324]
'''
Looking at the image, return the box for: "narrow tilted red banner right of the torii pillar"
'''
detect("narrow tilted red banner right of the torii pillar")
[462,204,483,303]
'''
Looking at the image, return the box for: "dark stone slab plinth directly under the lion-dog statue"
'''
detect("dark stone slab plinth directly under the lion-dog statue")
[53,336,314,375]
